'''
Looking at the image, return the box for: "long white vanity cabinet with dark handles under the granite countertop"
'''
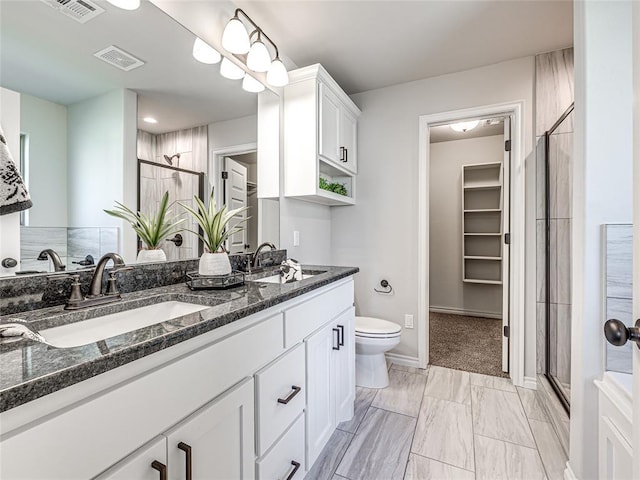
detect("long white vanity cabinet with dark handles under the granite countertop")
[0,278,355,480]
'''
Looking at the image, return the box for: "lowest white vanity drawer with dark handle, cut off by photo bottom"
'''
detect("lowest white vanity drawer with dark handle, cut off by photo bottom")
[257,415,306,480]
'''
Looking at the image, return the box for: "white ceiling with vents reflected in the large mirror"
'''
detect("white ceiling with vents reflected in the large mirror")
[0,0,257,133]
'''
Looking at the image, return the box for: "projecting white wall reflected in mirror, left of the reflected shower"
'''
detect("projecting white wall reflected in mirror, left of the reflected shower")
[67,89,137,262]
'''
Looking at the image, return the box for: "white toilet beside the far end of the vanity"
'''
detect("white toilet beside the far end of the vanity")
[356,317,402,388]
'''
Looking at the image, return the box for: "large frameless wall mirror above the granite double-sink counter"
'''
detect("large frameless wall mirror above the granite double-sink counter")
[0,0,279,278]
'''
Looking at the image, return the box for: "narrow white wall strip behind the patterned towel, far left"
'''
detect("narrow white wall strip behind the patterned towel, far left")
[0,87,20,275]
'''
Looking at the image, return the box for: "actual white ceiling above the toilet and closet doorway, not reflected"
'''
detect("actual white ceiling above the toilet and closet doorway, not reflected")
[232,0,573,94]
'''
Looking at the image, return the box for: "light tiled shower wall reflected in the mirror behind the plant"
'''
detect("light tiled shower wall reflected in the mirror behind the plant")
[138,126,208,260]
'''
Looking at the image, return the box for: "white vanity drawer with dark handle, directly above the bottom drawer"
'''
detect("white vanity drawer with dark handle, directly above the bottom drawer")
[256,344,306,456]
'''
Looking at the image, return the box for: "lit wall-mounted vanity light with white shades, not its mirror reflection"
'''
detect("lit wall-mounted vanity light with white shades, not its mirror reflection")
[222,8,289,87]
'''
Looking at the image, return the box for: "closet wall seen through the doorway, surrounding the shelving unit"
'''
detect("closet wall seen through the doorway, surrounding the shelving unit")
[429,135,504,316]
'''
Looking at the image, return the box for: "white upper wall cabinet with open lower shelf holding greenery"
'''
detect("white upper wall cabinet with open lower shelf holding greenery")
[284,64,360,205]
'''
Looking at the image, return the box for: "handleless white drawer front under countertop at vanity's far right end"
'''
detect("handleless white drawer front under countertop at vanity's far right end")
[284,280,353,348]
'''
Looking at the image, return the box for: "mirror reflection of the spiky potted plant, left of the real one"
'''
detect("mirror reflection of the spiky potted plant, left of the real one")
[105,192,185,263]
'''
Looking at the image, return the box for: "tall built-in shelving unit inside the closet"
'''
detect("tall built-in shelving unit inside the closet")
[462,162,503,285]
